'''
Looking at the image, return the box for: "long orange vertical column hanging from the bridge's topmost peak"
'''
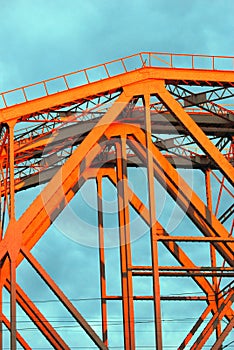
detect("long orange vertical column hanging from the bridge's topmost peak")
[144,94,162,350]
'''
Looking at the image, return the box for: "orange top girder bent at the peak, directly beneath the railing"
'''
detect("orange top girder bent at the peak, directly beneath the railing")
[0,67,234,123]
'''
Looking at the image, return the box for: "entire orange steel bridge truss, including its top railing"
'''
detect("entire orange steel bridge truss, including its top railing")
[0,52,234,350]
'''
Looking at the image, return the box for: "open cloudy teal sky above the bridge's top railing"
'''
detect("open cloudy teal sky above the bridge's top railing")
[0,0,234,91]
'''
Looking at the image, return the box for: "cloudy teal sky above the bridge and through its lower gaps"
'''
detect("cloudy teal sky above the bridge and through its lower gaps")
[0,0,234,349]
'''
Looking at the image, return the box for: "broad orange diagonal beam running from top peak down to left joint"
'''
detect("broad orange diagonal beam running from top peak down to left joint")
[0,93,132,266]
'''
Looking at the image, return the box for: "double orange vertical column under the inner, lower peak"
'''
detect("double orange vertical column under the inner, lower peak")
[116,135,135,350]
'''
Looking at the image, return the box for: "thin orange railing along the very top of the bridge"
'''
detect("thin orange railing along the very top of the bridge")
[0,52,234,109]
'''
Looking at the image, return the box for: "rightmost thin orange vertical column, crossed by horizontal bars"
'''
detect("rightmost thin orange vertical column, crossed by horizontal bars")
[205,169,222,339]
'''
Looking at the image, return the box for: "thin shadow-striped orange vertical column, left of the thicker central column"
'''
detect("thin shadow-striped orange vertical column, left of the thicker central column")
[96,175,108,346]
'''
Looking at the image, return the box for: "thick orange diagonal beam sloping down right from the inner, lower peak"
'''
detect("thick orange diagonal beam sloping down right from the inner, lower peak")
[129,131,234,266]
